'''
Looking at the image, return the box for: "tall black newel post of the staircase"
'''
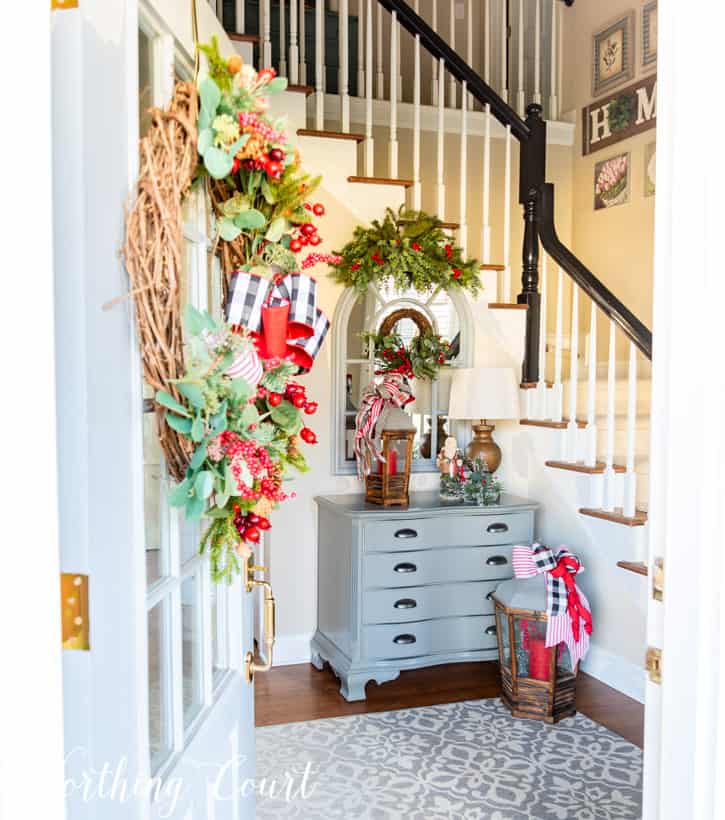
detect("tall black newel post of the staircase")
[516,103,546,384]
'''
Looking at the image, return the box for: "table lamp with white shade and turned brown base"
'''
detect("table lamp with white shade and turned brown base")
[448,367,519,473]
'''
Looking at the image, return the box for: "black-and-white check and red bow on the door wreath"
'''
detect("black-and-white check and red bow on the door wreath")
[227,270,330,372]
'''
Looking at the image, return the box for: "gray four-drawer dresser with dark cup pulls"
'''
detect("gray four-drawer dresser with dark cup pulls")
[312,492,537,701]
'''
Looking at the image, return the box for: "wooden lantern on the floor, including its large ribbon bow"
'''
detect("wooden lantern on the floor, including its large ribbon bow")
[493,547,591,723]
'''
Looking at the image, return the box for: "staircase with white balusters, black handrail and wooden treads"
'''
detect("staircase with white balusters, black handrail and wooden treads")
[216,0,651,574]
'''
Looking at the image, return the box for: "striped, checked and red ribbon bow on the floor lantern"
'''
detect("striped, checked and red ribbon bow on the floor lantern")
[513,544,592,664]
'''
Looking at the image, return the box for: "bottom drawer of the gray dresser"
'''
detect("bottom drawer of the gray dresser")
[363,615,498,660]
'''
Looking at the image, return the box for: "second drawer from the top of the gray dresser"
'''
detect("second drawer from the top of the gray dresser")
[363,544,513,589]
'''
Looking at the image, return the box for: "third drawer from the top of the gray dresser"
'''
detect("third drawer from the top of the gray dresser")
[363,580,501,624]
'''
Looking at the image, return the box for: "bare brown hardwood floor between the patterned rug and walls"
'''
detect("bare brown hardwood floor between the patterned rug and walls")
[255,662,644,748]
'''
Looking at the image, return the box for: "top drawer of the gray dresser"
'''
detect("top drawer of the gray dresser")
[363,512,533,552]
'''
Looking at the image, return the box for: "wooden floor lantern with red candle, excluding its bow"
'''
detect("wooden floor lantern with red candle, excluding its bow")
[493,577,577,723]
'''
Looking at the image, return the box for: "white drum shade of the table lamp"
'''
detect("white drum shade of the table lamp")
[448,367,520,420]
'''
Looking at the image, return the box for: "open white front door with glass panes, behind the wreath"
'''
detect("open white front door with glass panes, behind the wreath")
[52,0,254,820]
